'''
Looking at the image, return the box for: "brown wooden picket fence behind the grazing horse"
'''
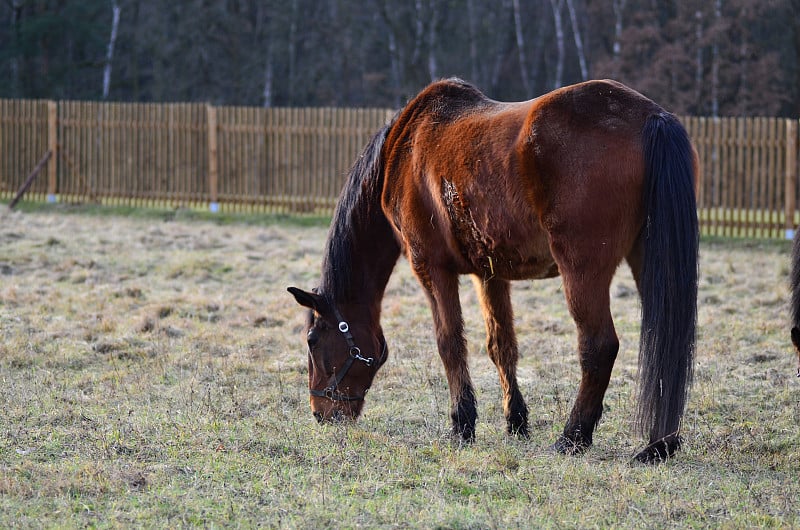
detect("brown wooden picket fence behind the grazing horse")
[0,100,800,238]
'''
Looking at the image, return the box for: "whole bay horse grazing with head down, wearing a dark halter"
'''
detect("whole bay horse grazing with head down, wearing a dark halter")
[289,79,698,462]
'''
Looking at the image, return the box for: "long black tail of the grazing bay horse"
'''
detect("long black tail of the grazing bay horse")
[637,112,699,447]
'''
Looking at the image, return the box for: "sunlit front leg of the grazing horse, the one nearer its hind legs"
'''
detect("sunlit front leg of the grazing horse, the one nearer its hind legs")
[472,276,528,438]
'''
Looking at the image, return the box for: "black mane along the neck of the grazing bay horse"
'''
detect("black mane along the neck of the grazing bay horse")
[319,117,396,302]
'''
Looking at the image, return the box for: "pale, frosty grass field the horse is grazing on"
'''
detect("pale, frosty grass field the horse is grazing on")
[0,205,800,528]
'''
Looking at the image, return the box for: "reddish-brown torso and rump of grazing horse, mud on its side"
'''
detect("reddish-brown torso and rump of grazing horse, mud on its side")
[382,80,660,279]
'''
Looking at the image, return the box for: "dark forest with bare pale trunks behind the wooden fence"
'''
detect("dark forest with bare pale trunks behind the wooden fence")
[0,0,800,117]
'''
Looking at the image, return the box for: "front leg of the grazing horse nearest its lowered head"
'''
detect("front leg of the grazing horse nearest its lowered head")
[412,264,478,442]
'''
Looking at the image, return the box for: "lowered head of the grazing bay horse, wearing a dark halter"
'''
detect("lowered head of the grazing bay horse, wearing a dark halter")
[289,287,387,422]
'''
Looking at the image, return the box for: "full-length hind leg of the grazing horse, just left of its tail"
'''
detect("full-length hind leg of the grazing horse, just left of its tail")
[553,258,619,454]
